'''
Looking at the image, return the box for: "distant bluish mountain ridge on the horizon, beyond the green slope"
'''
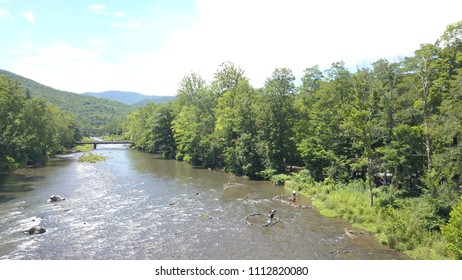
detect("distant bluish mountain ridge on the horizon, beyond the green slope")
[83,90,176,107]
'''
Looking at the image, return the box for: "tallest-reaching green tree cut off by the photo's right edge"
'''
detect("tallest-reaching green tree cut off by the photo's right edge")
[431,21,462,187]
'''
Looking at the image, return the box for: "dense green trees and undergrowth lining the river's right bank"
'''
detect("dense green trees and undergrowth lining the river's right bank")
[127,22,462,258]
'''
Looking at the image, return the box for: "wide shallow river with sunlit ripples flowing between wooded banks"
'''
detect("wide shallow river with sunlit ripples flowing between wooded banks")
[0,145,406,260]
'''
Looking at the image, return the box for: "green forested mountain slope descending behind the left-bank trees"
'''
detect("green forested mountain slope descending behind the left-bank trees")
[0,69,136,129]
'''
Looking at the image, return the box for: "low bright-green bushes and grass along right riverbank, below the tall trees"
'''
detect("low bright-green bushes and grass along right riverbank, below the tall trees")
[273,171,462,260]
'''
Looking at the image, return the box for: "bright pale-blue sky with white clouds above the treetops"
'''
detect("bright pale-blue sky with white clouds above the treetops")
[0,0,462,95]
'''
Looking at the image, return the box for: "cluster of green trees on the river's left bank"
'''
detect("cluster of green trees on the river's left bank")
[0,75,79,172]
